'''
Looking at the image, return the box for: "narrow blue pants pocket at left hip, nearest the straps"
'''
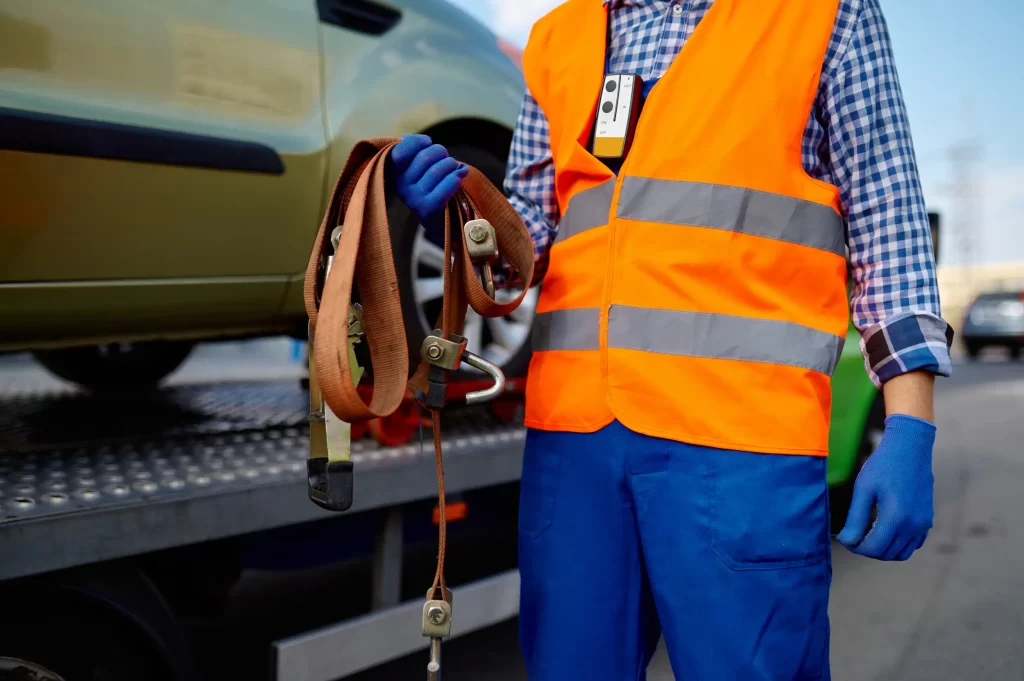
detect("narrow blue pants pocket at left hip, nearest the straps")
[519,430,563,539]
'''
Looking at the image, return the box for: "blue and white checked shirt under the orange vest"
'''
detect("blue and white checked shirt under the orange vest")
[505,0,952,385]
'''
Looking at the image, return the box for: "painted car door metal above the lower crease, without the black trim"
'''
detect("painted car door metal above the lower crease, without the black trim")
[0,0,327,280]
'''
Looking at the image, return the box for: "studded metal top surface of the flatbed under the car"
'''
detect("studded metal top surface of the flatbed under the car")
[0,382,524,526]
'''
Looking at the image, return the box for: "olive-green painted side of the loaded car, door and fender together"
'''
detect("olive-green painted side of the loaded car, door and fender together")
[0,0,523,349]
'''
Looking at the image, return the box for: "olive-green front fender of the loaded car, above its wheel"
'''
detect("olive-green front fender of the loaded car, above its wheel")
[280,0,525,324]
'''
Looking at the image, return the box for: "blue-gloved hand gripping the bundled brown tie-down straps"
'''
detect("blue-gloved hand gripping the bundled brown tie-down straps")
[388,135,469,247]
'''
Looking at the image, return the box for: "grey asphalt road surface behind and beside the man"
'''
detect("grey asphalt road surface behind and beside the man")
[353,361,1024,681]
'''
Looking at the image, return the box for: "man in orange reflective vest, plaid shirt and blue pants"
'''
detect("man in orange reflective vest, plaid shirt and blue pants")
[392,0,951,681]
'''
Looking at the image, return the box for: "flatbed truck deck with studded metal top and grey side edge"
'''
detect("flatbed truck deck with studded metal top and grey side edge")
[0,381,524,580]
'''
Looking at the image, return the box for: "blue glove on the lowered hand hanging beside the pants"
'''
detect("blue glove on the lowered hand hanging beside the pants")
[836,414,935,560]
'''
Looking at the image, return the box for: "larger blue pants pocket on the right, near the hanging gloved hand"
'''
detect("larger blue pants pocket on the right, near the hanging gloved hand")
[707,451,828,570]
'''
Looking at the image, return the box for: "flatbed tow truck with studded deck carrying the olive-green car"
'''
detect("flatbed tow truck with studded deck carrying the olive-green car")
[0,368,524,681]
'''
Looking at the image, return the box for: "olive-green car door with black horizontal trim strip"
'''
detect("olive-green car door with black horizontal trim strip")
[0,0,326,346]
